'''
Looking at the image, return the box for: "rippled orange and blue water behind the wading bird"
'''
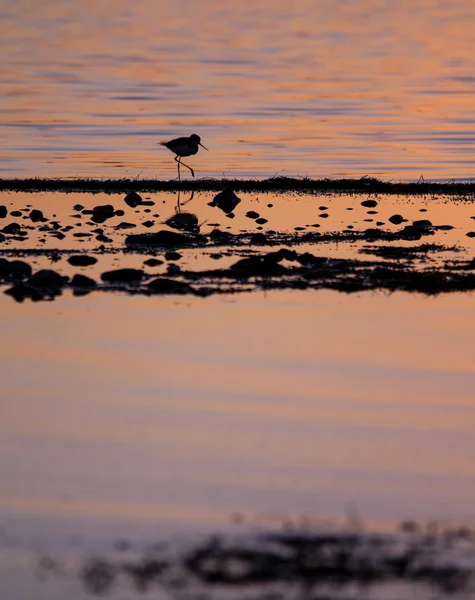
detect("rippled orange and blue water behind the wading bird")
[0,0,475,179]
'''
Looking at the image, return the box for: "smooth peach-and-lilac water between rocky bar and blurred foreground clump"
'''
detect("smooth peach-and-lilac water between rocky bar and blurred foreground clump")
[0,292,475,599]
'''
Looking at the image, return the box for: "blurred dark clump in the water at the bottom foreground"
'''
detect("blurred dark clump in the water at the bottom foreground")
[33,522,475,600]
